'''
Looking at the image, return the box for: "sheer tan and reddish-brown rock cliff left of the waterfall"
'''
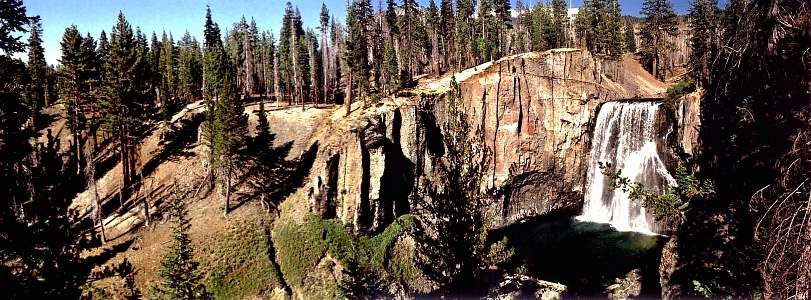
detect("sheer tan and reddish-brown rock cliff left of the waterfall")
[309,49,663,231]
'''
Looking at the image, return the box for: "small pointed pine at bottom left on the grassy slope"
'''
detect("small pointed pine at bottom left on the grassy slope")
[152,191,211,300]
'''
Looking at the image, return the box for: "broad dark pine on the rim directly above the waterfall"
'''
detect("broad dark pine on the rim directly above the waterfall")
[639,0,678,79]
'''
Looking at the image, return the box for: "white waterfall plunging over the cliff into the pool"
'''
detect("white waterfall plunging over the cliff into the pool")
[578,102,676,233]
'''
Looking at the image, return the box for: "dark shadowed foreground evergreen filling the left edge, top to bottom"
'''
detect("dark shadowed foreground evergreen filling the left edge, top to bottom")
[0,0,89,299]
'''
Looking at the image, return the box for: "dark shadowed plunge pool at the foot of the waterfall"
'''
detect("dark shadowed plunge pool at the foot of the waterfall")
[490,216,667,297]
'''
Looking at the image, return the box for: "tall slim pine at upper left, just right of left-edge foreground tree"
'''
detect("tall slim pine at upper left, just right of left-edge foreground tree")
[28,18,49,119]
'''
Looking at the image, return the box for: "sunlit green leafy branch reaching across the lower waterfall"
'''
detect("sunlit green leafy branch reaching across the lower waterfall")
[600,163,715,223]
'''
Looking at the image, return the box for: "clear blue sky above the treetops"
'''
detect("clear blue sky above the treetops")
[18,0,704,64]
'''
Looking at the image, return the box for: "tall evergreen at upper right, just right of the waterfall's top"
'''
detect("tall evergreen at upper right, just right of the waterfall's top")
[688,0,720,86]
